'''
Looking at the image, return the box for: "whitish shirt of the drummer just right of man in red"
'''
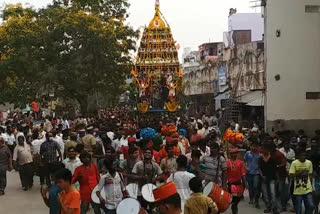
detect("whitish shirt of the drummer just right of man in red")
[98,172,125,210]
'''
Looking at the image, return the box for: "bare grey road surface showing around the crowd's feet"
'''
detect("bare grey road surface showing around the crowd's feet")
[0,172,292,214]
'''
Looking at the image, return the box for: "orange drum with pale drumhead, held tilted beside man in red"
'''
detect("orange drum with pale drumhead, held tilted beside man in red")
[203,182,232,212]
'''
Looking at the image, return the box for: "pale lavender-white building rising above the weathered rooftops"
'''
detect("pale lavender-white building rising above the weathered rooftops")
[223,11,264,48]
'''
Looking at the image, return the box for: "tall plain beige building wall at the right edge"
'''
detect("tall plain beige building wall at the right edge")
[263,0,320,135]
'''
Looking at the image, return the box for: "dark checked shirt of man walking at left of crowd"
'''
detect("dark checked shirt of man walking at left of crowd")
[40,141,59,163]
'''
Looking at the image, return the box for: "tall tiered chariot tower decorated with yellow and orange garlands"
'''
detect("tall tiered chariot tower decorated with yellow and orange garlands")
[131,0,183,113]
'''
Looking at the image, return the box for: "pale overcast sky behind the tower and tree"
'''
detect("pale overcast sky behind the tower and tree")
[0,0,257,49]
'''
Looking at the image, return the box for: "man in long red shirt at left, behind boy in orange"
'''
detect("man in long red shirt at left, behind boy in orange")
[72,151,101,214]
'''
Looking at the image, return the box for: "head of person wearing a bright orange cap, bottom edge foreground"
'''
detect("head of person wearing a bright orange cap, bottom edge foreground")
[153,182,182,214]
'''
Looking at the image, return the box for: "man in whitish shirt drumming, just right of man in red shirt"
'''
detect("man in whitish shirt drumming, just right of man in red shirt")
[96,157,128,214]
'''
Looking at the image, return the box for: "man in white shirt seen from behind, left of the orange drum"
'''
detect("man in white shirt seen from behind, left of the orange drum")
[167,155,195,211]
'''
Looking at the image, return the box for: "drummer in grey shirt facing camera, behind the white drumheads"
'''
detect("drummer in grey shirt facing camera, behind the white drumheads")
[132,147,164,208]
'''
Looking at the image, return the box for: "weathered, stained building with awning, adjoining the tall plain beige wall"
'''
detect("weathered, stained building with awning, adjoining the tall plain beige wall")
[220,41,265,126]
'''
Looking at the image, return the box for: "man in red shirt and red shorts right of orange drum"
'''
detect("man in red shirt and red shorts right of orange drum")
[226,148,246,214]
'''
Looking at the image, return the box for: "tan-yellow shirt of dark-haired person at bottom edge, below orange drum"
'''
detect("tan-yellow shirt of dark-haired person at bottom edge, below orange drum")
[184,193,218,214]
